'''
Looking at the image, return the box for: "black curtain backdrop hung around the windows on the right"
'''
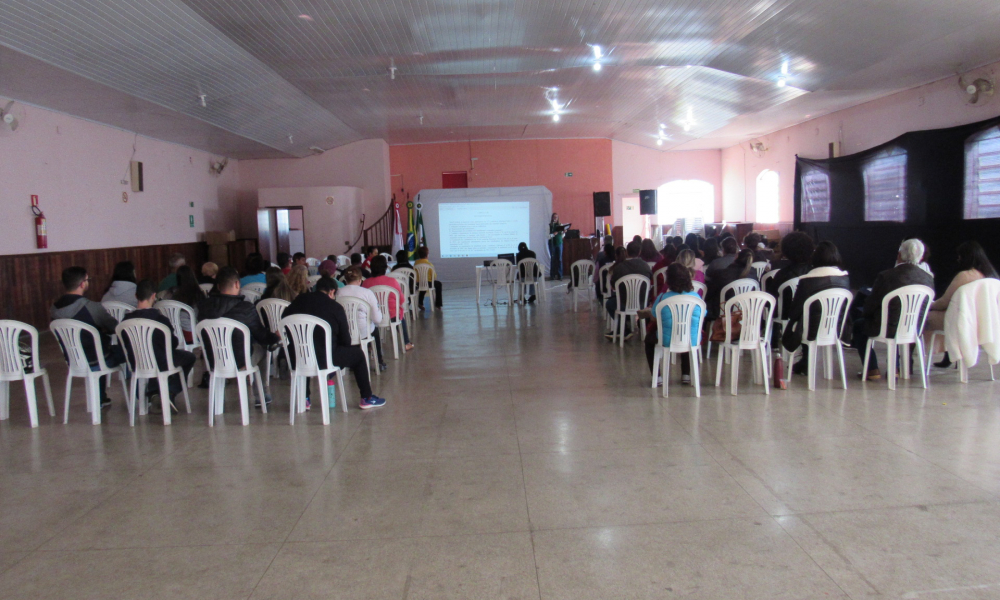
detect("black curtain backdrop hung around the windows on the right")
[795,117,1000,294]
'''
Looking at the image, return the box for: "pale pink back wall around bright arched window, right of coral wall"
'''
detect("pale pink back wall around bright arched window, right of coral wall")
[611,141,722,225]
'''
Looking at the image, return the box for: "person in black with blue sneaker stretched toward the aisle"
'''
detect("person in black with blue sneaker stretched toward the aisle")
[284,277,385,410]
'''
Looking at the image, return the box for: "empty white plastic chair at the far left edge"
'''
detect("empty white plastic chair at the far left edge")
[0,320,56,427]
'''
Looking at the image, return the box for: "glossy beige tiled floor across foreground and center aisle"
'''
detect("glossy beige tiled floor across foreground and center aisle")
[0,282,1000,600]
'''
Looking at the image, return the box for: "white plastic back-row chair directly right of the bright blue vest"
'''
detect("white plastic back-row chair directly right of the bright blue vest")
[715,291,774,396]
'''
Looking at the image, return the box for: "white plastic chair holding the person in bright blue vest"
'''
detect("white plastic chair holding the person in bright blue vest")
[650,295,708,398]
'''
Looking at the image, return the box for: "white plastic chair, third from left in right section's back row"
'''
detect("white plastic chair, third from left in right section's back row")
[781,288,854,391]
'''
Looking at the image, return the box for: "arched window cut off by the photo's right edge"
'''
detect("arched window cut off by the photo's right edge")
[964,126,1000,219]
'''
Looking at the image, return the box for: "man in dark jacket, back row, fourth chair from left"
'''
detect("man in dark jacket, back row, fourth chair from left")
[196,267,280,405]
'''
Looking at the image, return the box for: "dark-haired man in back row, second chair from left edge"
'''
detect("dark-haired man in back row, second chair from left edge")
[51,267,125,408]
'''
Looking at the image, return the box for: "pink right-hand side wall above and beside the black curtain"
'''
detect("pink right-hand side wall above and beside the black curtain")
[722,63,1000,221]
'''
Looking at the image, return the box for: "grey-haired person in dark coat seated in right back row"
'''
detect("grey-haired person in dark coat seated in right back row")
[856,239,934,381]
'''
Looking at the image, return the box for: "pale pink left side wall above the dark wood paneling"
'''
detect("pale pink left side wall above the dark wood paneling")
[0,98,239,254]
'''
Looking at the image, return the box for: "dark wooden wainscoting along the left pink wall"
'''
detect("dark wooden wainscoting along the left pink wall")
[0,242,208,330]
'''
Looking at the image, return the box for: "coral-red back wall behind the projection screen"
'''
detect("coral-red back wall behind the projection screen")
[389,139,612,235]
